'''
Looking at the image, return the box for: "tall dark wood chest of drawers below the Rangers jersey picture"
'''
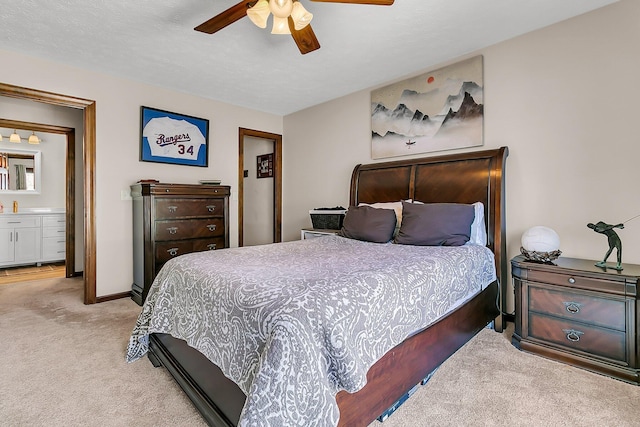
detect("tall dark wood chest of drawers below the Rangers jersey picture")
[131,182,230,305]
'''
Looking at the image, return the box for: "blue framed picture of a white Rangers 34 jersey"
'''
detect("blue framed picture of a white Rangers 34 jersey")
[140,106,209,167]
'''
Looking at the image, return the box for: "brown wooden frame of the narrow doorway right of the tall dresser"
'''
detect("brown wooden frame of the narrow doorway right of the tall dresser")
[238,128,282,246]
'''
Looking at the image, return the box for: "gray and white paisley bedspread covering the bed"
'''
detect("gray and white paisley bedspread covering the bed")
[127,236,496,427]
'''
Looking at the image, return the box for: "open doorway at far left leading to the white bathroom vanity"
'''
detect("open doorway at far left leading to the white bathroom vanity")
[0,117,76,283]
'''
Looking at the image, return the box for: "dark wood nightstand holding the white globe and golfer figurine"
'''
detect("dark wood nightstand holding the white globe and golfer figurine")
[511,256,640,385]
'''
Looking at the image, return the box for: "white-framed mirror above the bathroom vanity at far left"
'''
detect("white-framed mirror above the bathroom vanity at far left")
[0,147,42,195]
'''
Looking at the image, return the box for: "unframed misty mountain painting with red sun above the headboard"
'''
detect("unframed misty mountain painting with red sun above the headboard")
[371,56,484,159]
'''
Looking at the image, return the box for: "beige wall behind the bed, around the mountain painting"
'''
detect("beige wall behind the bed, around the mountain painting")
[283,0,640,309]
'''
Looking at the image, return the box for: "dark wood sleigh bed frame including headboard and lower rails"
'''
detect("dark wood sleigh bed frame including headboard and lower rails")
[149,147,508,427]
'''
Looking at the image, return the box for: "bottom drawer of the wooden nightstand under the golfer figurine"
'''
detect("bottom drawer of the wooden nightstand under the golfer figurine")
[528,313,627,362]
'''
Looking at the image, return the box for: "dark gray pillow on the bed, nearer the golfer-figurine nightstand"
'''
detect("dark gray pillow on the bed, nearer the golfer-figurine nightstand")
[395,202,475,246]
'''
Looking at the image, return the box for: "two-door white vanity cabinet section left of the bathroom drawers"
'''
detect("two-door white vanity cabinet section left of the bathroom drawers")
[0,215,42,267]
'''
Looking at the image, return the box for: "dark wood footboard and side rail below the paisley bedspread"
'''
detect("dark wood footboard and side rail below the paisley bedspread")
[149,282,499,427]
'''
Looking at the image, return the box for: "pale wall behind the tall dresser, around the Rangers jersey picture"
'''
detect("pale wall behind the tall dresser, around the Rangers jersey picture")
[0,51,282,297]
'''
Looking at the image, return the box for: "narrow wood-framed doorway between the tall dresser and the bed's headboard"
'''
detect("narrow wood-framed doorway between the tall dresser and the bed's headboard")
[238,128,282,246]
